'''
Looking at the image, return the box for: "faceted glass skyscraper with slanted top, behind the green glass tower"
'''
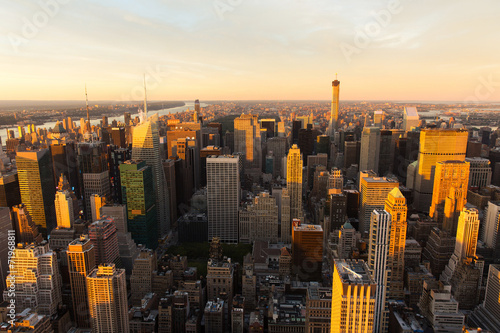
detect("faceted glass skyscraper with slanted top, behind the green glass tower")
[132,114,171,235]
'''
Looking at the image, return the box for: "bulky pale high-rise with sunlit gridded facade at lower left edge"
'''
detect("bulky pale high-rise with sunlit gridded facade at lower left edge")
[3,242,62,316]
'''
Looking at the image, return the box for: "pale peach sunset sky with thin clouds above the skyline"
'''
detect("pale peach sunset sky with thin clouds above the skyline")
[0,0,500,103]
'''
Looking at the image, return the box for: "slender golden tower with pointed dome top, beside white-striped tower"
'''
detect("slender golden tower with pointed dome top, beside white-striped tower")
[384,187,408,299]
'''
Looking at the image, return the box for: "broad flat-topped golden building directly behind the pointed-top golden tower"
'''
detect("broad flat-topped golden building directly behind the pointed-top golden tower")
[359,177,399,233]
